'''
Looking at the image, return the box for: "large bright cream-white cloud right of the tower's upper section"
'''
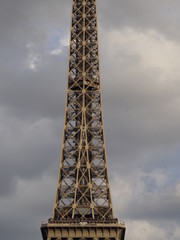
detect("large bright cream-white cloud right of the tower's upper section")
[103,28,180,95]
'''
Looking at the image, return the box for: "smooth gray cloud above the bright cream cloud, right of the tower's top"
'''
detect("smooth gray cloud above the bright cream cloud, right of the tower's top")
[98,0,180,40]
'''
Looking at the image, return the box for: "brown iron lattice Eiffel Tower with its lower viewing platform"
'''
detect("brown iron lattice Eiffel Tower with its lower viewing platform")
[41,0,125,240]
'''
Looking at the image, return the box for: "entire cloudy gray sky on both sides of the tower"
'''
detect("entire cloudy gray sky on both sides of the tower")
[0,0,180,240]
